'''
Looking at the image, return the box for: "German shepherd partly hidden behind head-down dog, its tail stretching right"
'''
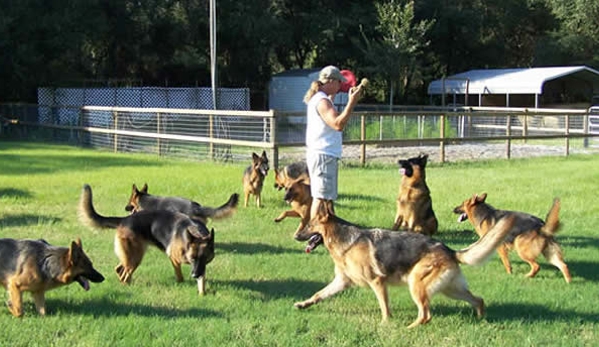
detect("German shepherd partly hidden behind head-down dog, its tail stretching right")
[125,184,239,224]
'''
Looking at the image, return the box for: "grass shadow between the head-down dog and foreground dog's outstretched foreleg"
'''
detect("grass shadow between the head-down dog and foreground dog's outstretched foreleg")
[213,279,328,300]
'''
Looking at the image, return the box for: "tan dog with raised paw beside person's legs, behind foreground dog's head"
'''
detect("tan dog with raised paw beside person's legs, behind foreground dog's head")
[275,176,312,234]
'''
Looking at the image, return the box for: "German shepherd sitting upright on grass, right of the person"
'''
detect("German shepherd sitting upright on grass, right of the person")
[392,155,438,236]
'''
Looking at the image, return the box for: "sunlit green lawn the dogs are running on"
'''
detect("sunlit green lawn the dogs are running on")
[0,142,599,346]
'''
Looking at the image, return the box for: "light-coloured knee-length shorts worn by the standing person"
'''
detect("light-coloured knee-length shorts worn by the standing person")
[306,152,339,200]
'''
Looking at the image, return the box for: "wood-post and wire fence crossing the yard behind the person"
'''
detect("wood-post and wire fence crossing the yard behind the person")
[0,104,599,167]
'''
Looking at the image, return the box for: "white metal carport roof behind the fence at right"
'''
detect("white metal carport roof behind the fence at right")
[428,66,599,95]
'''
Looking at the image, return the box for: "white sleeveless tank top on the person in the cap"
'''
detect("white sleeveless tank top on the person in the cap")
[306,91,343,158]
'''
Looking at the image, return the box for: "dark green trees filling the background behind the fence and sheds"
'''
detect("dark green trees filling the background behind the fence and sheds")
[0,0,599,109]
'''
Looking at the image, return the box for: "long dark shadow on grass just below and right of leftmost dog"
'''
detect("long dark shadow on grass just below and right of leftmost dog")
[46,298,221,318]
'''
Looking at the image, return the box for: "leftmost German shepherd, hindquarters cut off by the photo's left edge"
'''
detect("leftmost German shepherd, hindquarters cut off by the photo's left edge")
[0,239,104,317]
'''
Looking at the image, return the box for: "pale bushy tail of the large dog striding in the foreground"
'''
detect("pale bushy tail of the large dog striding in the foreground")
[456,216,516,265]
